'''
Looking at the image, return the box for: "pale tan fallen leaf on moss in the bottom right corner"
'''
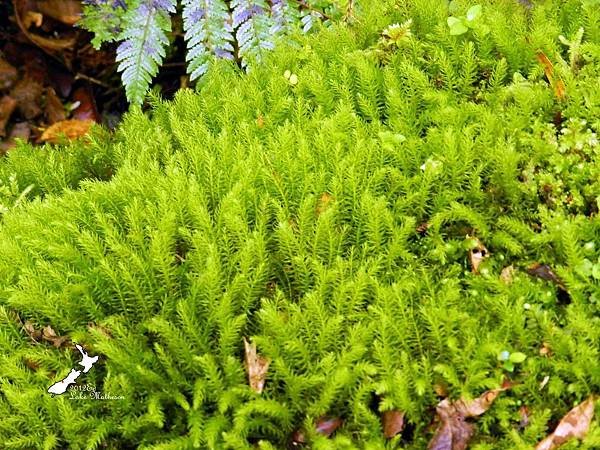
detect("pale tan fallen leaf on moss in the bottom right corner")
[535,396,594,450]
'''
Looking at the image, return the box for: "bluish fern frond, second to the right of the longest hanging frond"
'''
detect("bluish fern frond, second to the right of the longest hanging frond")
[231,0,275,69]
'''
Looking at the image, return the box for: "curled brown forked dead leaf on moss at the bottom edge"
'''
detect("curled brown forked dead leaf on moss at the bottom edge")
[427,382,512,450]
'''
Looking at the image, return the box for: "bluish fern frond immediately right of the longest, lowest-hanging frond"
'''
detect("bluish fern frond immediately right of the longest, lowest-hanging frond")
[182,0,234,80]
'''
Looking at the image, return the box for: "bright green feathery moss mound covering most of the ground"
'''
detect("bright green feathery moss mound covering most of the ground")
[0,0,600,450]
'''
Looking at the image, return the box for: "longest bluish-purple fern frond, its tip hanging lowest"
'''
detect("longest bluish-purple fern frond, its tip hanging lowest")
[116,0,176,104]
